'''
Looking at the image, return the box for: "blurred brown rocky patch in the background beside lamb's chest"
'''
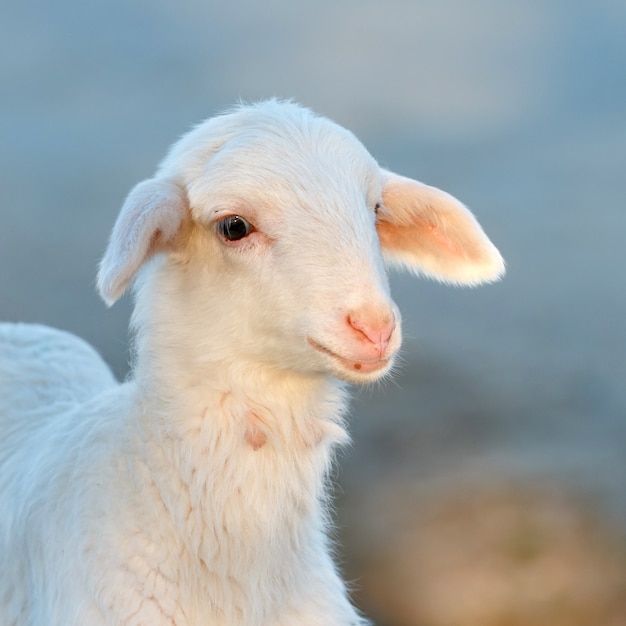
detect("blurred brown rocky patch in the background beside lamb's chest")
[342,477,626,626]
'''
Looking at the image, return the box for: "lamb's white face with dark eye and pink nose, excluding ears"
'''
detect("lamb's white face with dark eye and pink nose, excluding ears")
[179,118,401,382]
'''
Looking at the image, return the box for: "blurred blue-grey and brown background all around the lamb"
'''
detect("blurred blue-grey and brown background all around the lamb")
[0,0,626,626]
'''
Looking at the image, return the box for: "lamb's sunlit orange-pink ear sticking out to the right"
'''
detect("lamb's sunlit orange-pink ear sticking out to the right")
[377,171,504,285]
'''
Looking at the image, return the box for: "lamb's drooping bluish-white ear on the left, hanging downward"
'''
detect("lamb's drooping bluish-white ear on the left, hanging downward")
[98,178,188,306]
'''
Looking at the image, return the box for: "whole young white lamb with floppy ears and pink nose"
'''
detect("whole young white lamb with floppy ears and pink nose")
[0,100,504,626]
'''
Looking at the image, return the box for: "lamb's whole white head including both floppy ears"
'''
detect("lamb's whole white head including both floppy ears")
[98,101,504,382]
